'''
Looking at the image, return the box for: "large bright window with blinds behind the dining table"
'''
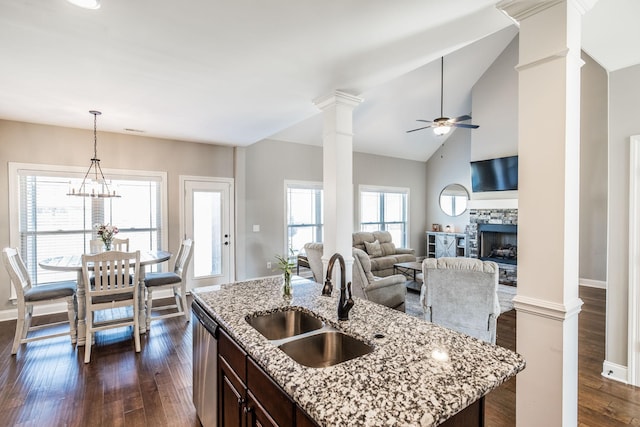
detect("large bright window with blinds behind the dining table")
[9,163,167,295]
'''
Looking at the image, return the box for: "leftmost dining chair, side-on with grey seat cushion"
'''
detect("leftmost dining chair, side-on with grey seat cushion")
[2,248,77,354]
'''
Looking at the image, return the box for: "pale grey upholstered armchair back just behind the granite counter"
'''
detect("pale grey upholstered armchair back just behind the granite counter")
[420,258,500,344]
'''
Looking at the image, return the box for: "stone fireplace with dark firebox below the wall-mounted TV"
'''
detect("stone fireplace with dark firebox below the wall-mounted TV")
[467,209,518,286]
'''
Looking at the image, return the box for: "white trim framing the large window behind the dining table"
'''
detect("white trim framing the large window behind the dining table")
[8,162,169,300]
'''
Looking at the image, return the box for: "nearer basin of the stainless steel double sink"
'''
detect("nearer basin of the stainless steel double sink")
[278,331,373,368]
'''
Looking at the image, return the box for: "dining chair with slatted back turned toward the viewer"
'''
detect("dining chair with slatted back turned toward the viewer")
[82,251,140,363]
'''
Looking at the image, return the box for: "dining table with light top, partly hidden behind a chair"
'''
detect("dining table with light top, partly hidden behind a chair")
[38,250,171,345]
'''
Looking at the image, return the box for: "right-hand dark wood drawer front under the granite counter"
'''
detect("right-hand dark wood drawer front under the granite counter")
[247,358,295,426]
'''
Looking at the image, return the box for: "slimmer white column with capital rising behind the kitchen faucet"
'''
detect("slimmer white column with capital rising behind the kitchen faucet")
[314,91,362,289]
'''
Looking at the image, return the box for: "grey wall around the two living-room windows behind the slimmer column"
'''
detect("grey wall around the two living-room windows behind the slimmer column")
[238,140,426,279]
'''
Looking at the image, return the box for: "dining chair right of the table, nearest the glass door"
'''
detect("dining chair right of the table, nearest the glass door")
[144,239,193,330]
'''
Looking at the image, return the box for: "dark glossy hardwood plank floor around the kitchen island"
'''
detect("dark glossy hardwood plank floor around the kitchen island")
[0,288,640,427]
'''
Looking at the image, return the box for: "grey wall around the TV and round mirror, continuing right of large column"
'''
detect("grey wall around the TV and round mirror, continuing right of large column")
[426,37,608,284]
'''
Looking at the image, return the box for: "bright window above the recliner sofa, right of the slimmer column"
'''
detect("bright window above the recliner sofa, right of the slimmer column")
[360,187,409,247]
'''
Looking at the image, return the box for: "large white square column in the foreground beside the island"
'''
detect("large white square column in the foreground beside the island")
[497,0,586,427]
